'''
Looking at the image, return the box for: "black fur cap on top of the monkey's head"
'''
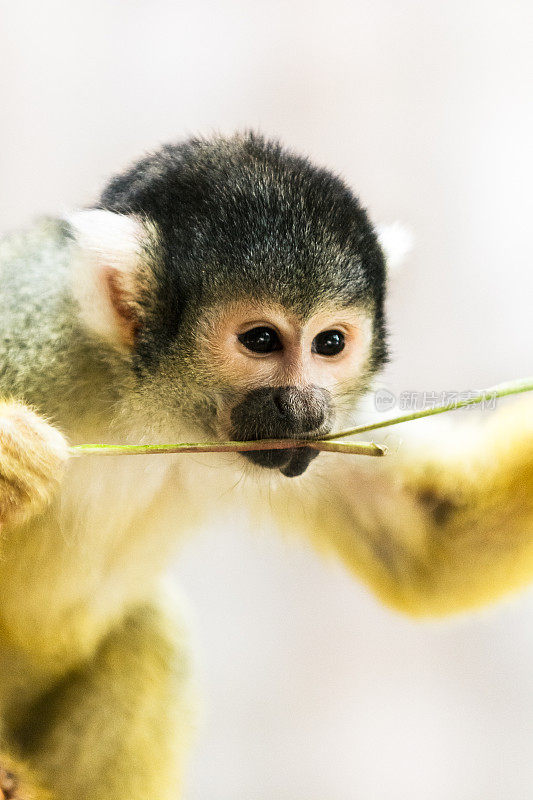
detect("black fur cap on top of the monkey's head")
[98,133,386,368]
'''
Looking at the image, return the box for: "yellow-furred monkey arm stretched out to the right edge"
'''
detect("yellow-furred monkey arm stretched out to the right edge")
[277,398,533,615]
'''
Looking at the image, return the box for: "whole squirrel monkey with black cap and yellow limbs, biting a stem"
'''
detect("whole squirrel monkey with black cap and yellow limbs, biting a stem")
[0,134,533,800]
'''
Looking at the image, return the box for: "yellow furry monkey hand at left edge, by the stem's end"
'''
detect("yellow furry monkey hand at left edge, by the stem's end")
[0,401,68,527]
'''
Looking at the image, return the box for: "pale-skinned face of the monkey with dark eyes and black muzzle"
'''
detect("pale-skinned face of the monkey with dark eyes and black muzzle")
[187,302,371,477]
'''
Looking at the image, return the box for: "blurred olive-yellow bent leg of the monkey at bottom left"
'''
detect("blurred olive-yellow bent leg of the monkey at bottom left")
[12,595,196,800]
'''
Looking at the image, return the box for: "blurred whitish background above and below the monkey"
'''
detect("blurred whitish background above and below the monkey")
[0,0,533,800]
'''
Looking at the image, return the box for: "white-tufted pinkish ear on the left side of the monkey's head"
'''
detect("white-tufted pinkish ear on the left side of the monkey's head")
[65,209,146,350]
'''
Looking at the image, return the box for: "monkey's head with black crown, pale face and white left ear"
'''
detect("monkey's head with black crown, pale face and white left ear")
[71,134,386,476]
